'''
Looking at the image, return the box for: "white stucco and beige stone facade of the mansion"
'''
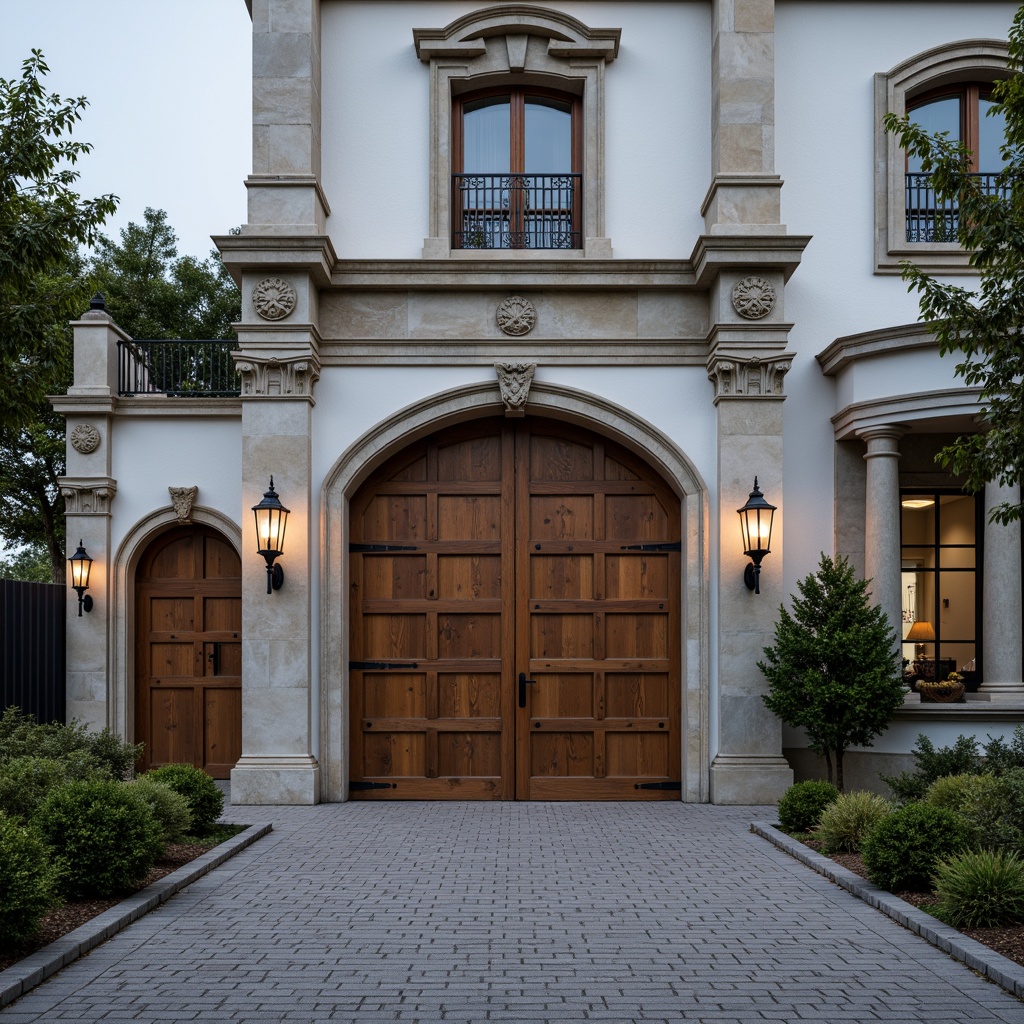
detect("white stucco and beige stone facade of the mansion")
[56,0,1024,803]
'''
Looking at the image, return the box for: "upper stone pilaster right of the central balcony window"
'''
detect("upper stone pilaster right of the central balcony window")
[700,0,785,234]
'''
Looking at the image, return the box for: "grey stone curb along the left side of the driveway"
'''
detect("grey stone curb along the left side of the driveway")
[0,822,272,1007]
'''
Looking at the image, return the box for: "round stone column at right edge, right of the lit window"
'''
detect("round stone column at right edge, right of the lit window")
[978,480,1024,700]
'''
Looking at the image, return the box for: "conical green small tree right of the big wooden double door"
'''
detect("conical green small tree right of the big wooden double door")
[758,553,903,791]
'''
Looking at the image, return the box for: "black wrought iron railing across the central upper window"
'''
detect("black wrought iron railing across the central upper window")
[452,174,583,249]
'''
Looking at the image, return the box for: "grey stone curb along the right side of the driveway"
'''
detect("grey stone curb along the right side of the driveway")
[751,821,1024,998]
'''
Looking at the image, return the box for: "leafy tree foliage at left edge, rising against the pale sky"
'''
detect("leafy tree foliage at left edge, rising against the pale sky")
[0,50,117,426]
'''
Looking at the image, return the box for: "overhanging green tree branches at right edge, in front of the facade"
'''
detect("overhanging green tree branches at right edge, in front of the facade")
[885,7,1024,523]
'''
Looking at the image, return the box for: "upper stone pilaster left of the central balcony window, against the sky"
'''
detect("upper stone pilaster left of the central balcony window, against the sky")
[243,0,330,234]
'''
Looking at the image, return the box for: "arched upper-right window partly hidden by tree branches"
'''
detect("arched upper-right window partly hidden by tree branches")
[906,82,1007,242]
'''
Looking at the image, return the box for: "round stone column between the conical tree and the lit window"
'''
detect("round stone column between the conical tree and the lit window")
[857,424,905,630]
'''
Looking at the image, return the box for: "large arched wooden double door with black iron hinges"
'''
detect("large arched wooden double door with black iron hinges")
[349,419,681,800]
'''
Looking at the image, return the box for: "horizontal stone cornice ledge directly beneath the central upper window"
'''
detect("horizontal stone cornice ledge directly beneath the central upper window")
[332,260,696,291]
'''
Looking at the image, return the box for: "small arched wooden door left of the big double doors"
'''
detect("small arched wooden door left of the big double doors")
[135,525,242,778]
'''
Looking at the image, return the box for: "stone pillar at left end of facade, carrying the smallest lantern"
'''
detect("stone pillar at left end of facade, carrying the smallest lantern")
[52,296,128,736]
